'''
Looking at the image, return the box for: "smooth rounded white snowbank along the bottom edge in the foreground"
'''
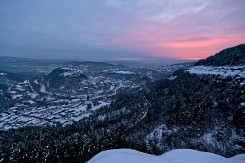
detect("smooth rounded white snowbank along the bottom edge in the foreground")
[88,149,245,163]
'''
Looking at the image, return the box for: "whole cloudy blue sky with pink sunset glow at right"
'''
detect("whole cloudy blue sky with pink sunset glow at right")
[0,0,245,60]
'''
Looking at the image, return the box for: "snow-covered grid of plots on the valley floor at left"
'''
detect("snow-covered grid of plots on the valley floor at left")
[0,101,110,131]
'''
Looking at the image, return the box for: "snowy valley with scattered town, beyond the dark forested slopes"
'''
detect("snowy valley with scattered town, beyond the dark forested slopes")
[0,58,191,131]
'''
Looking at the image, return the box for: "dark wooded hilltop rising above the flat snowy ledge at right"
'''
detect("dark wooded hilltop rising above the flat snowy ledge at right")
[195,44,245,66]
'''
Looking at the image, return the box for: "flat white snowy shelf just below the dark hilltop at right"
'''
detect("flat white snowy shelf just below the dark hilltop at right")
[187,66,245,78]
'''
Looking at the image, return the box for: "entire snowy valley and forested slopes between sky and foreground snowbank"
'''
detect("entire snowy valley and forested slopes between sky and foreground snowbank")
[0,44,245,162]
